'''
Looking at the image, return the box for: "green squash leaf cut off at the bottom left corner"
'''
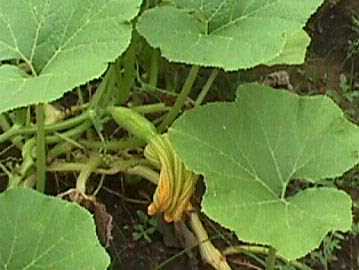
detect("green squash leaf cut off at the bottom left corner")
[0,188,110,270]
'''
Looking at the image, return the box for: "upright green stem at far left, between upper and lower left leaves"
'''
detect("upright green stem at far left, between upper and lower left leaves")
[36,104,46,192]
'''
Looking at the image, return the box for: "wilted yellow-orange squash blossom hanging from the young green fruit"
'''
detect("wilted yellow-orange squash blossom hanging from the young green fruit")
[145,134,198,222]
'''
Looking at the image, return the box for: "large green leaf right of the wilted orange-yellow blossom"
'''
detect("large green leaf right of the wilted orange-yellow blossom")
[170,84,359,259]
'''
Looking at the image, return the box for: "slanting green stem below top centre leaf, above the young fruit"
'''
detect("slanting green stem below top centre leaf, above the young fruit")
[159,66,199,132]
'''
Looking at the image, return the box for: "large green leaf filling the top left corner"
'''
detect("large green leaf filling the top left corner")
[0,0,141,112]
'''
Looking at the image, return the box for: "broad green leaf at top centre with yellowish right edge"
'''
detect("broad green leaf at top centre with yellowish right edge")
[137,0,323,70]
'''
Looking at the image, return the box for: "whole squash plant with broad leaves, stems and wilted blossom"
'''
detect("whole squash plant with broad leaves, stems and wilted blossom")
[0,0,359,269]
